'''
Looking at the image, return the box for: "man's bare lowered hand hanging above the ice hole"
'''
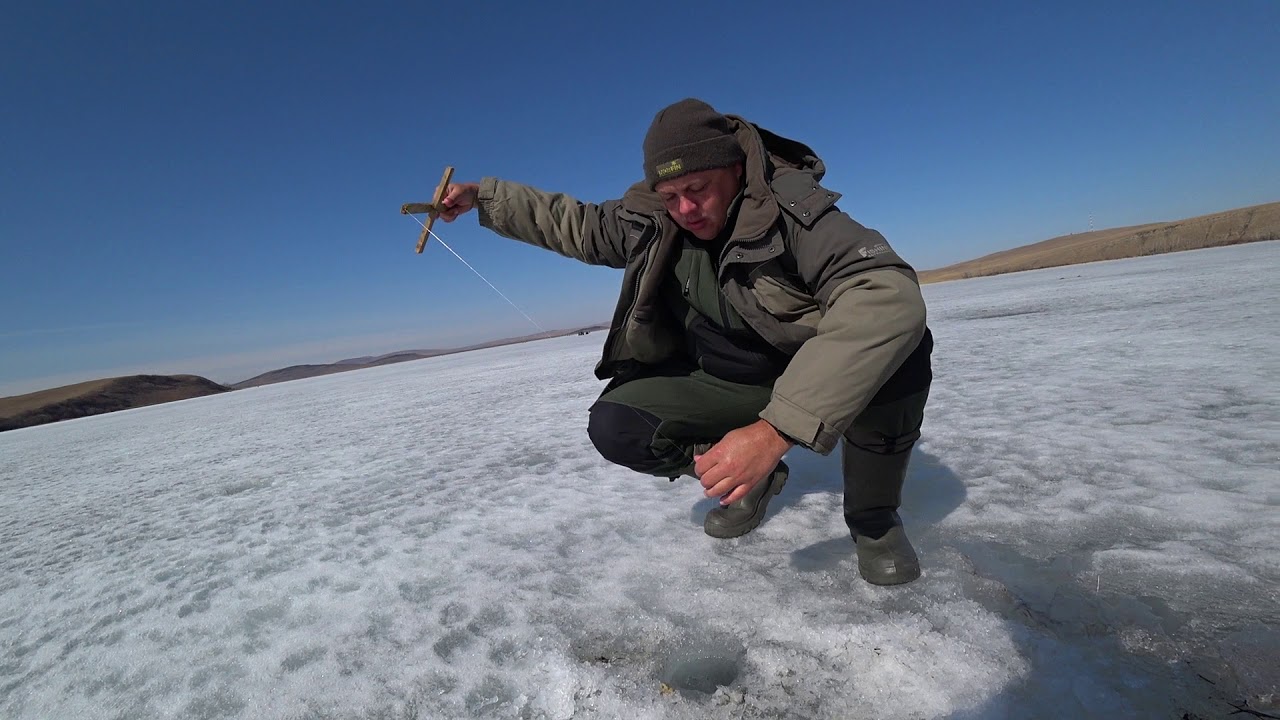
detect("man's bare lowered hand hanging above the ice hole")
[694,420,791,505]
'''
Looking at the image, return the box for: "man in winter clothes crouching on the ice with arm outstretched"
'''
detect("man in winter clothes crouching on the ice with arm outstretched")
[442,99,933,584]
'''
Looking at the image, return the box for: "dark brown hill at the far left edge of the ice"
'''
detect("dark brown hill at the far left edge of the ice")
[0,375,232,432]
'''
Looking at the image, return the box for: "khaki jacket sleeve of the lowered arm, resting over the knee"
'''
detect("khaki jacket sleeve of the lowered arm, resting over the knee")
[760,211,925,455]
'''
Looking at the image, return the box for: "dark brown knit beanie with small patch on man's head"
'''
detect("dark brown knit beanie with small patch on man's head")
[644,97,746,190]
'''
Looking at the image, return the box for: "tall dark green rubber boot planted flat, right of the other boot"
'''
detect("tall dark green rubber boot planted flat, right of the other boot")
[841,441,920,585]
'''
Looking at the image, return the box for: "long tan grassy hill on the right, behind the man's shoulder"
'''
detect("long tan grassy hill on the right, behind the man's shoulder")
[920,202,1280,282]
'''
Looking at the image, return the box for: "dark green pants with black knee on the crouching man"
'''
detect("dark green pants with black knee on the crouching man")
[588,368,928,478]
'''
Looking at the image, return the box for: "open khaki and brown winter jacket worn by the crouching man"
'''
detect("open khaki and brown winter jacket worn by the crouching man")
[477,115,932,455]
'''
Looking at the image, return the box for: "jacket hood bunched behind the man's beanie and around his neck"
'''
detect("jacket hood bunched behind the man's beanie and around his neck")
[622,115,827,238]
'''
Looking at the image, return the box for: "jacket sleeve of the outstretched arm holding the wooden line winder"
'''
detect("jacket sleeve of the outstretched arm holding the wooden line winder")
[476,178,627,268]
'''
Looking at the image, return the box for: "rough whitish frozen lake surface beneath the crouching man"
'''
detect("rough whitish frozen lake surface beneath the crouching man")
[0,242,1280,720]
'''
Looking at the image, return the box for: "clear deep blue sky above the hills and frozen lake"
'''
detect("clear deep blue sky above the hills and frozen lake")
[0,0,1280,395]
